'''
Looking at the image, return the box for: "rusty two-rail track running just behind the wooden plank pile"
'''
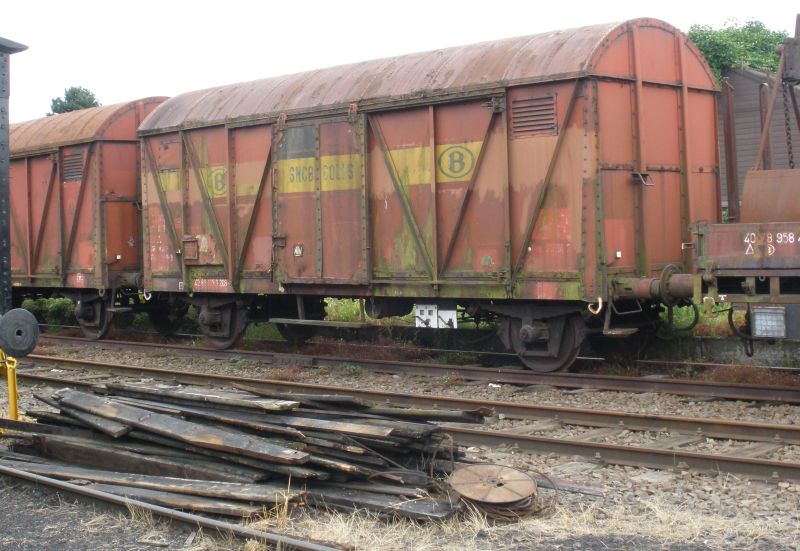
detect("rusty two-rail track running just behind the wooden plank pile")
[10,356,800,480]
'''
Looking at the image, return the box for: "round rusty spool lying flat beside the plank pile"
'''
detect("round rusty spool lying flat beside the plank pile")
[449,464,536,509]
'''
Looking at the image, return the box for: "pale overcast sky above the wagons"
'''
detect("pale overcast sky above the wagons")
[0,0,798,122]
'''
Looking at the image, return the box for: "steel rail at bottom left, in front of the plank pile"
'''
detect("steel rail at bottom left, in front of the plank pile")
[0,465,342,551]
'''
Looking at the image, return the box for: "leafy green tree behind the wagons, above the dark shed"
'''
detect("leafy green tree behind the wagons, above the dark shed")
[688,21,788,81]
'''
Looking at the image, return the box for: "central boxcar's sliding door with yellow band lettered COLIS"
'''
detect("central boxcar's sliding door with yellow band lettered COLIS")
[273,120,366,283]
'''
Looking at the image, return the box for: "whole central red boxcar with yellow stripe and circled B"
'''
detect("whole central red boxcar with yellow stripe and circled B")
[139,19,720,370]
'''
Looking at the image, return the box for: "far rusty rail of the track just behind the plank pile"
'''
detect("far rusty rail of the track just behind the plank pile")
[17,358,800,444]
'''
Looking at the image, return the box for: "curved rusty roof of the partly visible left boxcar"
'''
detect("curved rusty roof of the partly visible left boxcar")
[9,97,166,156]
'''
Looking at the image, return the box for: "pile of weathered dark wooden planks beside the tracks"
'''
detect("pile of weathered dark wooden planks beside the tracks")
[0,382,489,519]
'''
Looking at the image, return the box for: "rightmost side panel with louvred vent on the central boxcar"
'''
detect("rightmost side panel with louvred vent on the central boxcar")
[508,81,585,299]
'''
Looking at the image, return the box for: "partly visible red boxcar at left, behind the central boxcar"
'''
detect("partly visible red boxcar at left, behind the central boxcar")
[10,98,165,338]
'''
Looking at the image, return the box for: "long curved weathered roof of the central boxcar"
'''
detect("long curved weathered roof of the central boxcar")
[140,19,621,132]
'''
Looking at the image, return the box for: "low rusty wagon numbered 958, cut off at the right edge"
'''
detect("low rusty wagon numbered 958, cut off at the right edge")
[691,30,800,355]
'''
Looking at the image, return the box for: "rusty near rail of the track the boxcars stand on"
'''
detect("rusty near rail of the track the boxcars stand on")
[36,336,800,404]
